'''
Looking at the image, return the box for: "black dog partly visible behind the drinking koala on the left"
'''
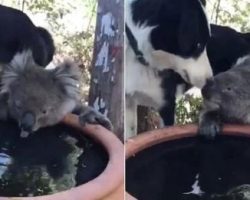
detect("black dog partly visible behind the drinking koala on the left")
[0,5,55,66]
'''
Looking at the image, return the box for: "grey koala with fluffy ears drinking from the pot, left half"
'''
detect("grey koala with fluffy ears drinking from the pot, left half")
[0,51,112,137]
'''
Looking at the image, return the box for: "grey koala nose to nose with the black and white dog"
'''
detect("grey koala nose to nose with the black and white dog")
[199,55,250,139]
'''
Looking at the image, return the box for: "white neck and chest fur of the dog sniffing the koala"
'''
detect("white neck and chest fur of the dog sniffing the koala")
[125,0,163,107]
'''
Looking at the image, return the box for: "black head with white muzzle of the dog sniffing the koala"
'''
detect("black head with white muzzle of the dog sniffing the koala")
[146,0,212,88]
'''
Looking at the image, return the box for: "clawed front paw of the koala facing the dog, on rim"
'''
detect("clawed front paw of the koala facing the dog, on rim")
[199,115,221,140]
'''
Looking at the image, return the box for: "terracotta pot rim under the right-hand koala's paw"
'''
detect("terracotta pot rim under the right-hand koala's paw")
[125,125,250,200]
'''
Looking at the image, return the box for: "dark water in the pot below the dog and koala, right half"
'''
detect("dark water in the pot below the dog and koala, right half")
[126,136,250,200]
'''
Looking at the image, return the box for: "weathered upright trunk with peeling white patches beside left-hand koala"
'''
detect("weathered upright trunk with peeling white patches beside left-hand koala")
[89,0,124,140]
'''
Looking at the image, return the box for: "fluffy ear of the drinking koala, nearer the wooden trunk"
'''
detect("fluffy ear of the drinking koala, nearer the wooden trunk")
[53,60,80,99]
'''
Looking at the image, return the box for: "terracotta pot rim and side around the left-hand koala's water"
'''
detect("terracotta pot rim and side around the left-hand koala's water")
[0,114,124,200]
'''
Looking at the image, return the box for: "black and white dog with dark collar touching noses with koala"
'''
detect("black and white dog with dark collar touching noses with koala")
[125,0,212,137]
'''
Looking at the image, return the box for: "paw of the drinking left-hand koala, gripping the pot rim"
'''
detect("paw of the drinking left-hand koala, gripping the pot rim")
[79,107,113,130]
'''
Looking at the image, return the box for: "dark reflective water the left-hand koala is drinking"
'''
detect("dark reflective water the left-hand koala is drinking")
[0,119,108,196]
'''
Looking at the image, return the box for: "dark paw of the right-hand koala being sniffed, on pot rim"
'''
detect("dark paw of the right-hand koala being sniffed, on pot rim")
[198,113,221,140]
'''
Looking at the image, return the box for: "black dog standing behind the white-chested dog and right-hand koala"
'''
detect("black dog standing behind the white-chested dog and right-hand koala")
[160,24,250,129]
